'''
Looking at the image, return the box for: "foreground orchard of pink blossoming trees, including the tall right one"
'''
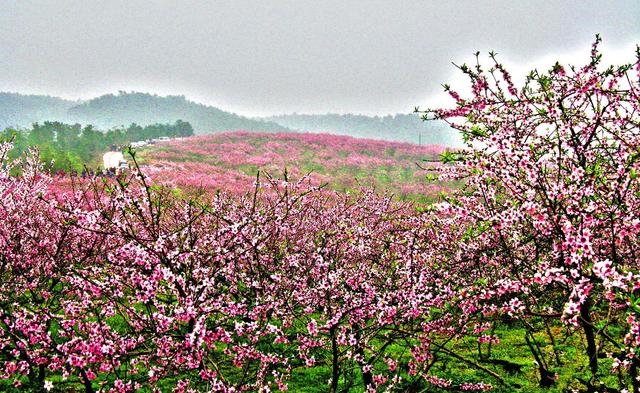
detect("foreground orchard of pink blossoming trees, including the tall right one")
[0,37,640,393]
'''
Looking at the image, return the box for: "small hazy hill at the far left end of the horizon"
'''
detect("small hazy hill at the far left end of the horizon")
[0,92,78,131]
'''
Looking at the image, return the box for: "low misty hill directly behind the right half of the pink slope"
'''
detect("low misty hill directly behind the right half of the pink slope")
[262,114,462,147]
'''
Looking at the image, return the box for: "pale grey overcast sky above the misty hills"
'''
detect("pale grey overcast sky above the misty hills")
[0,0,640,116]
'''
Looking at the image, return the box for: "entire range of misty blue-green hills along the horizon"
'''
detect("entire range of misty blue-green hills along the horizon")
[0,91,460,146]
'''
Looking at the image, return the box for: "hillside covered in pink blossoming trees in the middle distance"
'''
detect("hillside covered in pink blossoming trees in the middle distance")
[138,130,454,201]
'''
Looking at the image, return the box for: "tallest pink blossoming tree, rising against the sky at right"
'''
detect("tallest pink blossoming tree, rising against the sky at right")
[424,37,640,392]
